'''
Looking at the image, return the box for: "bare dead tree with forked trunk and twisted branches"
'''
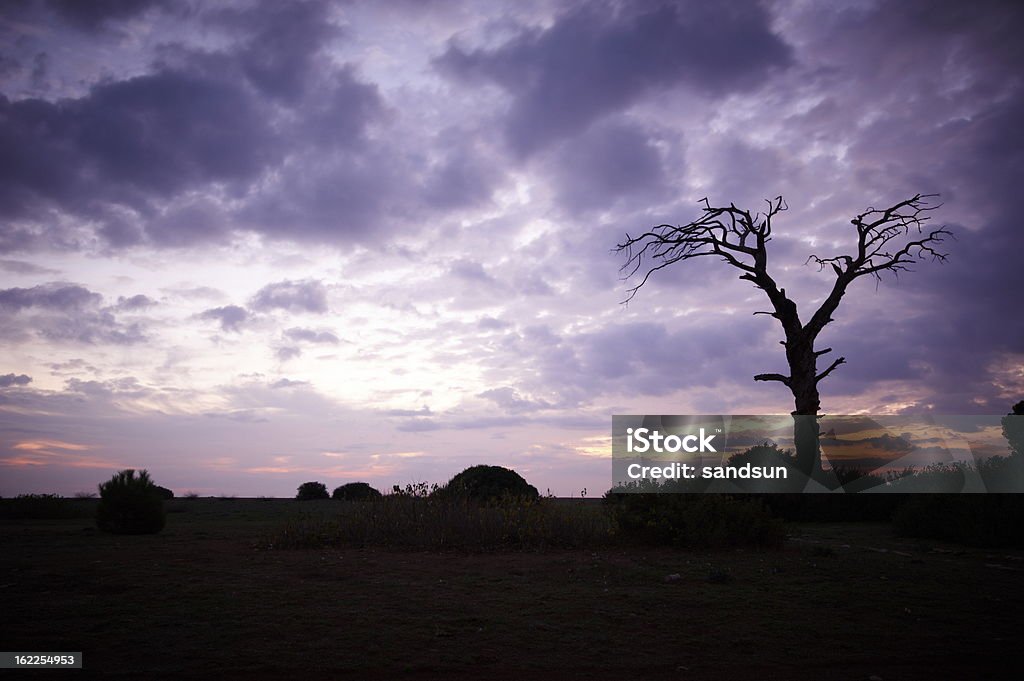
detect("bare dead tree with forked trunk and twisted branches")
[615,194,951,475]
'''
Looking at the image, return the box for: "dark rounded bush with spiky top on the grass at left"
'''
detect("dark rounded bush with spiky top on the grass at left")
[96,468,166,535]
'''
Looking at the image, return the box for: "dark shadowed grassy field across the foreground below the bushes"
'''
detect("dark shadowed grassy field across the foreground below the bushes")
[0,499,1024,681]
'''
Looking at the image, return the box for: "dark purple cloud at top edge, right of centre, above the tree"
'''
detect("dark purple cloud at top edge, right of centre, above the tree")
[435,2,792,155]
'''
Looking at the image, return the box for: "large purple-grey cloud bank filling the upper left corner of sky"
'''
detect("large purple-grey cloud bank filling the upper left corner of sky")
[0,2,391,252]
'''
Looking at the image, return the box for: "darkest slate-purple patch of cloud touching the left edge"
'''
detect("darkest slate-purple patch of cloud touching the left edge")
[0,71,274,240]
